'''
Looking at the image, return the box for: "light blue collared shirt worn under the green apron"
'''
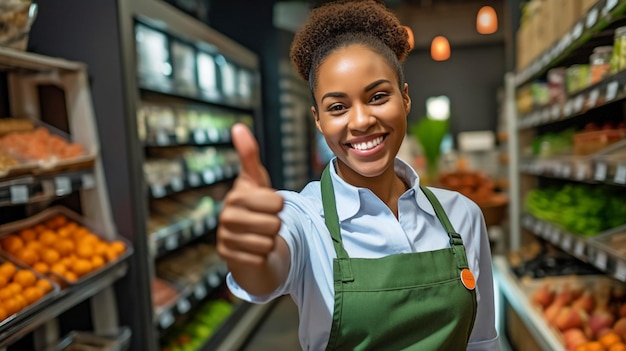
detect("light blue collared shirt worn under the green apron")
[226,158,499,351]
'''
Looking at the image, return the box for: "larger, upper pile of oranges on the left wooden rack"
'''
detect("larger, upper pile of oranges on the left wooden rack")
[0,214,126,285]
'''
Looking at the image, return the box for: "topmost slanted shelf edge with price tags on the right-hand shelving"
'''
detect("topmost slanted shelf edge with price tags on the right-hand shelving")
[515,0,626,87]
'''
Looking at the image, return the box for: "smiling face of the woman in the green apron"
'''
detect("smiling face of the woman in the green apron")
[311,44,411,186]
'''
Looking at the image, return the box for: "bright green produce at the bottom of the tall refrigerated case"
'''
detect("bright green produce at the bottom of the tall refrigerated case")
[161,299,234,351]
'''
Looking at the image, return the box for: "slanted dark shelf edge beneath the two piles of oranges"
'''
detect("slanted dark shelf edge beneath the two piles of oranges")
[0,261,128,347]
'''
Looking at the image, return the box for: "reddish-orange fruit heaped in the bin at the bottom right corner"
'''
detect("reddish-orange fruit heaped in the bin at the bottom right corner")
[528,276,626,351]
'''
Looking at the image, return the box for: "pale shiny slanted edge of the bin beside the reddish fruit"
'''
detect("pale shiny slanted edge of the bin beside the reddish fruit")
[493,255,565,351]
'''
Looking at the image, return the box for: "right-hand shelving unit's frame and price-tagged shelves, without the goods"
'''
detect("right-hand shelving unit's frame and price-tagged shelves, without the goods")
[494,0,626,350]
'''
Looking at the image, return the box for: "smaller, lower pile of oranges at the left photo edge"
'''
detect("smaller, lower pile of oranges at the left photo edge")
[0,262,53,322]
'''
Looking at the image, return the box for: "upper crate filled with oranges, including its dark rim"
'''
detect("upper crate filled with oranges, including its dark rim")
[0,206,132,288]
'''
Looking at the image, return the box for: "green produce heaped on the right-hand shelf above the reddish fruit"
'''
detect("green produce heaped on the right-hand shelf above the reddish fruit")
[524,184,626,236]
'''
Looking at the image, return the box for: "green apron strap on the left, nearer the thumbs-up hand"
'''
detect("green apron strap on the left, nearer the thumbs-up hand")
[321,163,354,282]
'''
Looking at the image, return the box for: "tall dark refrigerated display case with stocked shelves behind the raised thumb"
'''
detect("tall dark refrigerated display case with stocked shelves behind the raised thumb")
[22,0,272,350]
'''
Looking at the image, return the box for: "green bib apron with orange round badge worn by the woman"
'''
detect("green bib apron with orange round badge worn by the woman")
[321,167,477,351]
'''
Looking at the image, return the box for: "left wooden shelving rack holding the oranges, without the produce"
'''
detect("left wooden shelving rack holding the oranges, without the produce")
[0,47,132,350]
